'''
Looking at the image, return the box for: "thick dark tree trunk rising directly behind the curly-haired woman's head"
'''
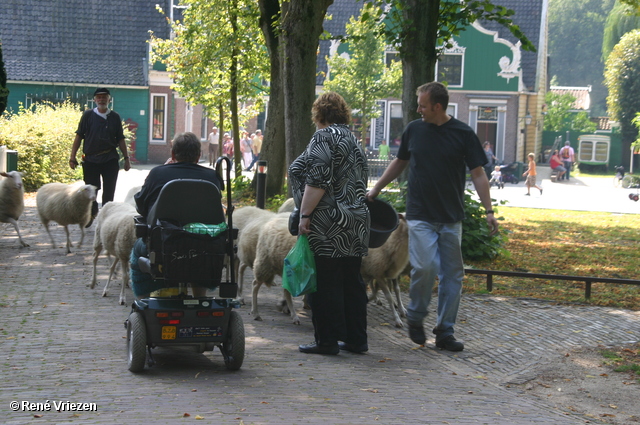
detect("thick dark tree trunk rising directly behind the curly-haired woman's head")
[281,0,333,192]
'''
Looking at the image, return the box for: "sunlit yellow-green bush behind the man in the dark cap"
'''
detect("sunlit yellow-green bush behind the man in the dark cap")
[0,101,131,192]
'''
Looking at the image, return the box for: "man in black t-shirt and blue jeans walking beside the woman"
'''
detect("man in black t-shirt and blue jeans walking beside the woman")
[367,82,498,351]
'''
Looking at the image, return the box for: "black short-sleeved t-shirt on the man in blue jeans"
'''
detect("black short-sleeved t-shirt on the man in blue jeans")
[397,117,487,223]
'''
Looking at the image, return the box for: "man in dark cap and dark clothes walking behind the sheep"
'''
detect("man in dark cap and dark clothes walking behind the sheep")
[69,88,131,227]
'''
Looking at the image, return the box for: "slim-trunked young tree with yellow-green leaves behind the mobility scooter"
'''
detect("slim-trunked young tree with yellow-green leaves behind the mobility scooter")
[152,0,269,175]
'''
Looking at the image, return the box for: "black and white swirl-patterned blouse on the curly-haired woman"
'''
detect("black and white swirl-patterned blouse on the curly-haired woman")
[289,124,370,257]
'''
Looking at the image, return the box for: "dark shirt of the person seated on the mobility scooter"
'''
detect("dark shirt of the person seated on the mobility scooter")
[134,162,222,217]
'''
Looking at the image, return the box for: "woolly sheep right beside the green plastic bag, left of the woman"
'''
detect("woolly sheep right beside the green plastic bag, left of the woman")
[251,213,300,325]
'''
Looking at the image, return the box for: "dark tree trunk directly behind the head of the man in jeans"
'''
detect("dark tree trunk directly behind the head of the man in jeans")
[400,0,440,126]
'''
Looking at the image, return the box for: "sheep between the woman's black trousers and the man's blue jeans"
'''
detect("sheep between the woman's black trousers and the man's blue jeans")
[360,214,409,328]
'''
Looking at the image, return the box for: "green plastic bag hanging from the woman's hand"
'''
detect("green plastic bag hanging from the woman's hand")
[282,235,317,297]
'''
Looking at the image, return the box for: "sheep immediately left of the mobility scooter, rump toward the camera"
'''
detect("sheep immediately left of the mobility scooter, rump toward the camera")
[89,202,137,305]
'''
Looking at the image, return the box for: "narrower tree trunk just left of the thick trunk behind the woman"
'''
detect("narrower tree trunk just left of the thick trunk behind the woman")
[260,0,287,197]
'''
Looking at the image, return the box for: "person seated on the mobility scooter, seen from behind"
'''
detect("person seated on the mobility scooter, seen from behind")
[130,132,222,298]
